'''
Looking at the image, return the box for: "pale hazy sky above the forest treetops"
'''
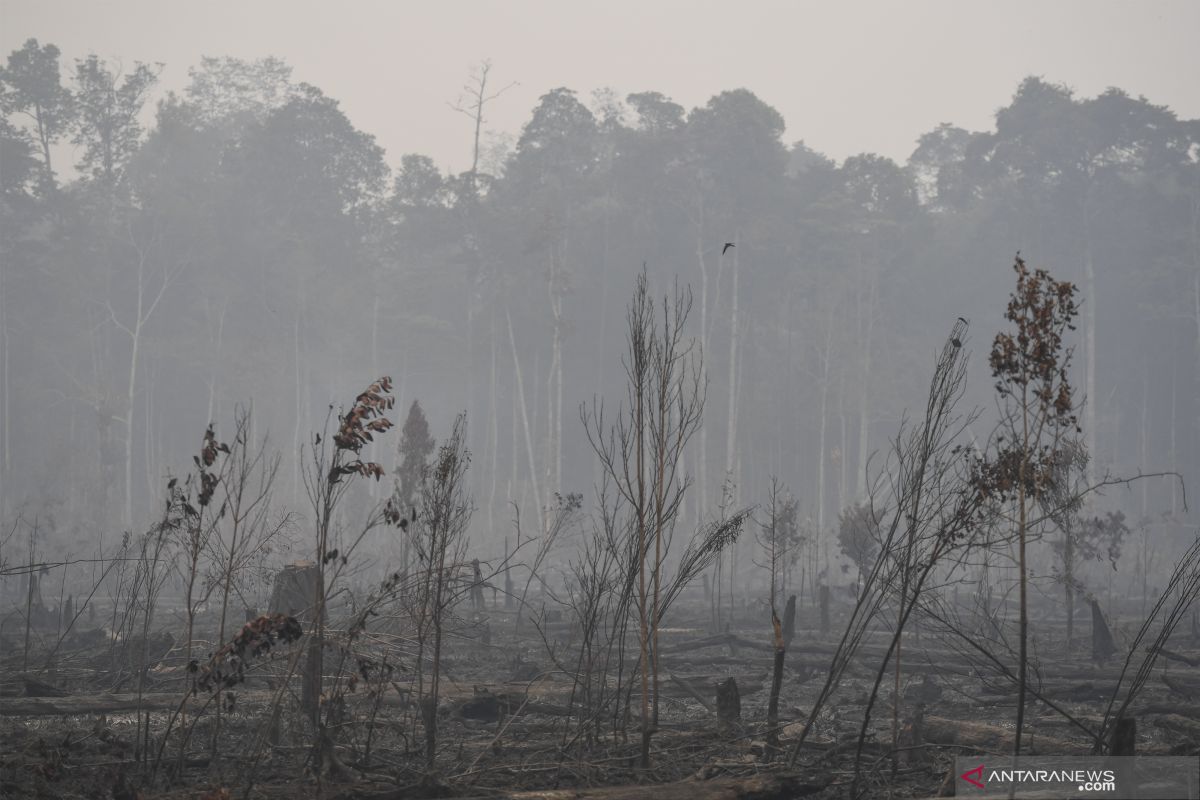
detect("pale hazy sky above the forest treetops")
[0,0,1200,169]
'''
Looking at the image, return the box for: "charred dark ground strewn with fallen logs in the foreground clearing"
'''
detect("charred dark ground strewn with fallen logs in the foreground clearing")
[0,596,1200,800]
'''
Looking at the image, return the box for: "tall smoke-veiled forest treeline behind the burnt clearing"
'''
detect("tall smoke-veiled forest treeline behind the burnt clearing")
[0,40,1200,566]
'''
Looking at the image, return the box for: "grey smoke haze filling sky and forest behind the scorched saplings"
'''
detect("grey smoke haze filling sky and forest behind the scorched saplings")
[0,2,1200,575]
